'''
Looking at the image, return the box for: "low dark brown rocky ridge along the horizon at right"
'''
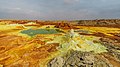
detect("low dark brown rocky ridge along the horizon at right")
[78,19,120,27]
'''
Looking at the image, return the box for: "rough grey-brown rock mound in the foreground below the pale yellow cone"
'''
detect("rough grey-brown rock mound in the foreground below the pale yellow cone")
[48,51,112,67]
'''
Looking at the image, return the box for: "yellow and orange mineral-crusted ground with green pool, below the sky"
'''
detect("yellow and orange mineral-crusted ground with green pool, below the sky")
[0,19,120,67]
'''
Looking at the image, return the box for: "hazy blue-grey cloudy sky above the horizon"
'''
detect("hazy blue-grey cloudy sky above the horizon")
[0,0,120,20]
